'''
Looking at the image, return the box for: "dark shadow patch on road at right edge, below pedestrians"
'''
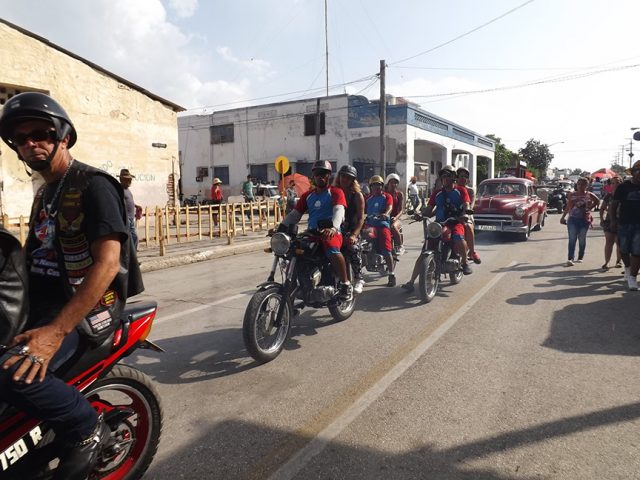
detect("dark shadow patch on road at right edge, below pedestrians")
[542,292,640,356]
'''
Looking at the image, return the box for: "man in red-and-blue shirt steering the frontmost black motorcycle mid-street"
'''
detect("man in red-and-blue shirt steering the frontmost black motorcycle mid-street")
[282,160,353,302]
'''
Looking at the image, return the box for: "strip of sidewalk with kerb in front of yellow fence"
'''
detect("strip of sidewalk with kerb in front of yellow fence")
[138,231,269,272]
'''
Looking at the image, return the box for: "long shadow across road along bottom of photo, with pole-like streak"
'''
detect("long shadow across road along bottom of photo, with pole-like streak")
[148,403,640,480]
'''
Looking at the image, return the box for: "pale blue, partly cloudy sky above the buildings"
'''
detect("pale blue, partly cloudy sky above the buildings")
[0,0,640,170]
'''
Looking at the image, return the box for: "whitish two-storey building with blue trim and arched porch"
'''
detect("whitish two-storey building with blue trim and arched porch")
[178,94,495,198]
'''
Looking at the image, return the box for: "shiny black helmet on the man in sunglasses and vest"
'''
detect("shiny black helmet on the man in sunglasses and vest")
[0,92,78,150]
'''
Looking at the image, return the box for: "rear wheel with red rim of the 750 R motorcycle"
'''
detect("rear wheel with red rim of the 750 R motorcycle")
[86,365,162,480]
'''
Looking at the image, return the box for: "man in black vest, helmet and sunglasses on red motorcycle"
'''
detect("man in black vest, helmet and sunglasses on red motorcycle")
[0,92,142,480]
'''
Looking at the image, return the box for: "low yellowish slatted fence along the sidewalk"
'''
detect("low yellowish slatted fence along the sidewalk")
[2,200,283,255]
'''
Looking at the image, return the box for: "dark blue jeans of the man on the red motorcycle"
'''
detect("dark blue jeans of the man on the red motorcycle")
[0,308,98,443]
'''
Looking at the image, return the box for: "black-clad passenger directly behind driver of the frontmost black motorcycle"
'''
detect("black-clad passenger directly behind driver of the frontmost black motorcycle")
[336,165,364,293]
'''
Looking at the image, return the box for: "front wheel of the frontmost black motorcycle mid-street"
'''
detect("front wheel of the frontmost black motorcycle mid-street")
[242,285,291,363]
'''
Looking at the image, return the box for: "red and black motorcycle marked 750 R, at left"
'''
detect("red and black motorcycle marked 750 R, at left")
[0,302,163,480]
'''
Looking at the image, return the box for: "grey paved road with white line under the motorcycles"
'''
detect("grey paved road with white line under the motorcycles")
[130,215,640,480]
